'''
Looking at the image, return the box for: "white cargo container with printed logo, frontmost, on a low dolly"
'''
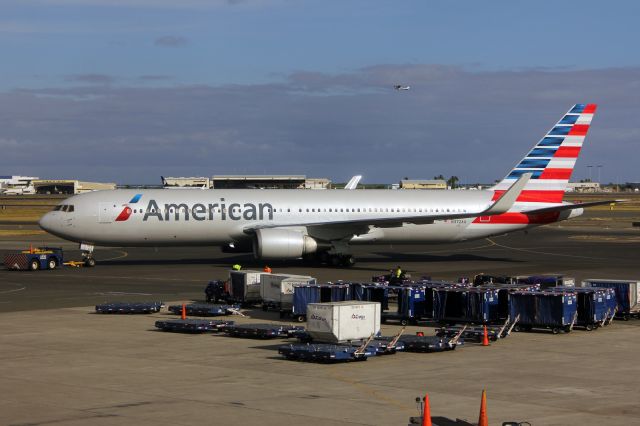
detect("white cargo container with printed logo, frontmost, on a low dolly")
[307,301,382,343]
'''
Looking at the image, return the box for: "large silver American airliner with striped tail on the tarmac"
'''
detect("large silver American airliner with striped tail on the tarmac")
[40,104,611,265]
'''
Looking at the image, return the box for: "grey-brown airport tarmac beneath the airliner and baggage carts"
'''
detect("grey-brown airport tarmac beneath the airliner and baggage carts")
[0,227,640,426]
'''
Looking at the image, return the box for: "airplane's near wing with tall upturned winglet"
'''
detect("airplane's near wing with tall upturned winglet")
[244,173,532,235]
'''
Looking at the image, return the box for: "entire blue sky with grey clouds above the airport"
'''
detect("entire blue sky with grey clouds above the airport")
[0,0,640,184]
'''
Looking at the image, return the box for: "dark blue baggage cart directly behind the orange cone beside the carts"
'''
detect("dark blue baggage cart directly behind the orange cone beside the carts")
[433,287,500,324]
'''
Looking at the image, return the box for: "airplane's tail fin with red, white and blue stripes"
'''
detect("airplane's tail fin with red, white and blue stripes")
[492,104,597,206]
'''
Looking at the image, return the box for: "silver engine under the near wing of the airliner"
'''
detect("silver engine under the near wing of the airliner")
[253,229,318,259]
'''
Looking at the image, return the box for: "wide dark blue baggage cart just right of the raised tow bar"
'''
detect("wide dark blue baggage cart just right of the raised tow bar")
[509,291,578,334]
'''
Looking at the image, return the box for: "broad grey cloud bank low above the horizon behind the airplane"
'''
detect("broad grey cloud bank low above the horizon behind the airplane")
[0,64,640,183]
